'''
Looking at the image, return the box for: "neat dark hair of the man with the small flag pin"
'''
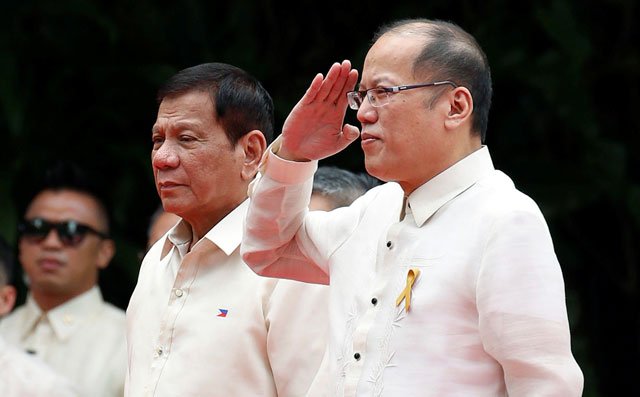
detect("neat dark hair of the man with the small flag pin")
[157,63,274,146]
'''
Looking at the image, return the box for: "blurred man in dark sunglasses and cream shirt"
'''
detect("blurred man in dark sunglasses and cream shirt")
[0,163,126,397]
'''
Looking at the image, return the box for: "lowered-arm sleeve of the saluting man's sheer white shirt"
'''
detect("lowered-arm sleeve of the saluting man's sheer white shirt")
[476,207,584,397]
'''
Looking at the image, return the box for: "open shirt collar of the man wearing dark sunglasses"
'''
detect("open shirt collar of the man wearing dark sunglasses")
[23,286,103,340]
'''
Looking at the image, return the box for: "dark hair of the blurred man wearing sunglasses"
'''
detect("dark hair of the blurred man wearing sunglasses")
[22,160,111,235]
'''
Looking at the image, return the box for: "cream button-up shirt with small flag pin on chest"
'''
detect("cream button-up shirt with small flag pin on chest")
[126,201,328,397]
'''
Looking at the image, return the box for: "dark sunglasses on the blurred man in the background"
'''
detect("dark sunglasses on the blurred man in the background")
[18,218,109,247]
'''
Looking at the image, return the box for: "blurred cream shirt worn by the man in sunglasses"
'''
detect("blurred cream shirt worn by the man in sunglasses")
[0,287,126,397]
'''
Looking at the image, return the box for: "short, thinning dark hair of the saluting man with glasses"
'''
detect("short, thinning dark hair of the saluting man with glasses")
[373,19,493,142]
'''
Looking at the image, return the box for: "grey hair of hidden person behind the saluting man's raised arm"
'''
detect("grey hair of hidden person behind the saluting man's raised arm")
[312,166,377,208]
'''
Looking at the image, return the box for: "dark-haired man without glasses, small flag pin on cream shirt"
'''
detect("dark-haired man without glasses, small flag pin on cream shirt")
[126,63,328,397]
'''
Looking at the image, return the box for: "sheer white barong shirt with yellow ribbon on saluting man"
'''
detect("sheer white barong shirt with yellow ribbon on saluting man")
[241,147,583,397]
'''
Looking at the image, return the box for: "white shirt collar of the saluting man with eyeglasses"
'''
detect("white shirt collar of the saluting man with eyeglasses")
[407,146,495,227]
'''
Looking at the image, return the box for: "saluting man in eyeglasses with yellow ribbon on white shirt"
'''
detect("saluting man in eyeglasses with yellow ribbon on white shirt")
[242,19,583,397]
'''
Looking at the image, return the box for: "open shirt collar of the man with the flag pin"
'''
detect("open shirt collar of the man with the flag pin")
[160,199,249,258]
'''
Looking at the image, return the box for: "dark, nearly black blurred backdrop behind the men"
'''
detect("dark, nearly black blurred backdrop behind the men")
[0,0,640,396]
